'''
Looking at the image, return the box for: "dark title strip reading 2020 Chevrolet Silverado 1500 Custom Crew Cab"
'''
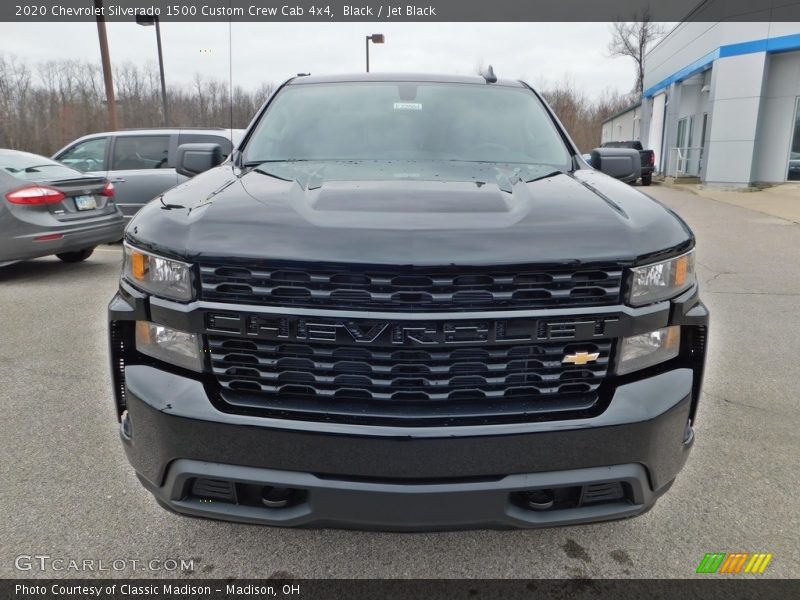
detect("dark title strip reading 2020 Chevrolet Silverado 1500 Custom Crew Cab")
[0,0,800,22]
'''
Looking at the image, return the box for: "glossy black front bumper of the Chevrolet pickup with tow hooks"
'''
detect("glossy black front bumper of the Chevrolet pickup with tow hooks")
[109,289,708,530]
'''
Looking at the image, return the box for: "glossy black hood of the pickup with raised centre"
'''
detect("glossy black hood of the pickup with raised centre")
[126,161,693,265]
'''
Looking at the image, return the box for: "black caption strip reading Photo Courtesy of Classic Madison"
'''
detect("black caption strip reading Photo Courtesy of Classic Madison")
[0,575,800,600]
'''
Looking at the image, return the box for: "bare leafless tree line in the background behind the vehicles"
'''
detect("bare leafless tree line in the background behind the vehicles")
[0,54,631,156]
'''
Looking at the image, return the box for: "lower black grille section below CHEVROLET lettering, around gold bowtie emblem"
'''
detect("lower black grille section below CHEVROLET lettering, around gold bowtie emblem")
[208,335,612,423]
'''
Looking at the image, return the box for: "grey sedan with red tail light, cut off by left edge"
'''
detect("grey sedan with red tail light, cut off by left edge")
[0,149,125,266]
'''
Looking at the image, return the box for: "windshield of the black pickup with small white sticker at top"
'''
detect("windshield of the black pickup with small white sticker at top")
[243,82,571,170]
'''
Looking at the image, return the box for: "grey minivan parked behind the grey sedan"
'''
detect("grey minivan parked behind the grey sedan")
[53,128,244,219]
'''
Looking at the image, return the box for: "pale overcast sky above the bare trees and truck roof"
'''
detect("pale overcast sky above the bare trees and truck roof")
[0,22,664,97]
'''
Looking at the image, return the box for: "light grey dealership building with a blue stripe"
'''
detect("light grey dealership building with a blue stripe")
[616,21,800,187]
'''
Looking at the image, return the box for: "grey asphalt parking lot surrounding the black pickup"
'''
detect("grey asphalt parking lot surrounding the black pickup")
[0,186,800,578]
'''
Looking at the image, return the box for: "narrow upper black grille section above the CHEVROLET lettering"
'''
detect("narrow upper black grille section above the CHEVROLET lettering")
[200,261,622,312]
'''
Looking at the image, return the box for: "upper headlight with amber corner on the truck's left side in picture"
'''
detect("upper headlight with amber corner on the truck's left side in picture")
[122,244,194,301]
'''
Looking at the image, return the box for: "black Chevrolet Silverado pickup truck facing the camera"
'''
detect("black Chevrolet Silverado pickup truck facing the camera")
[109,74,708,530]
